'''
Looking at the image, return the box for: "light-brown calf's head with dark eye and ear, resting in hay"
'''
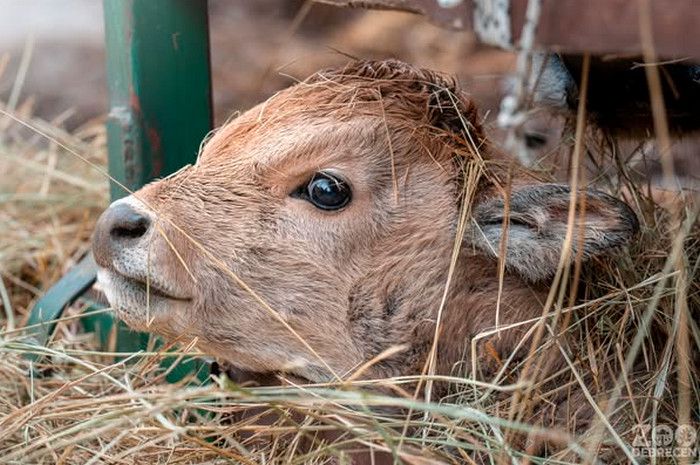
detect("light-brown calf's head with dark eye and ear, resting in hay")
[94,61,636,381]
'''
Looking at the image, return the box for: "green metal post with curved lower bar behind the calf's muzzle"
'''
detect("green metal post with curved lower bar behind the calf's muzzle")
[28,0,213,376]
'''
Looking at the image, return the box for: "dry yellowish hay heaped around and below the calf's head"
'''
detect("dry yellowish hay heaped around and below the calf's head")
[0,85,700,464]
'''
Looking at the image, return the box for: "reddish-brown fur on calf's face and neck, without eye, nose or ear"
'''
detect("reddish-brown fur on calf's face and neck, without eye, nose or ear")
[97,61,628,436]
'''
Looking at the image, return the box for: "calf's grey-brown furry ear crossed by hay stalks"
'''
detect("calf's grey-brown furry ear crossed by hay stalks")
[465,184,639,282]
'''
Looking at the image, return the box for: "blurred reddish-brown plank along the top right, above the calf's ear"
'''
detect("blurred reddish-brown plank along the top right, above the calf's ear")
[322,0,700,58]
